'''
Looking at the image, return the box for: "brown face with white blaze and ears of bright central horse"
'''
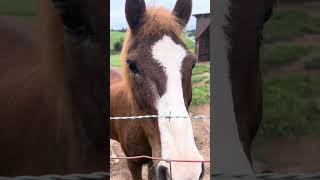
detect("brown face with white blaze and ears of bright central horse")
[123,0,203,180]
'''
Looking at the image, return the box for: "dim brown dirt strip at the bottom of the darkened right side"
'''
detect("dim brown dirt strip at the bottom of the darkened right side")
[254,136,320,173]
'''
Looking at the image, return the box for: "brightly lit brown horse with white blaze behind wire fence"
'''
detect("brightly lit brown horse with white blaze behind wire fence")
[110,0,204,180]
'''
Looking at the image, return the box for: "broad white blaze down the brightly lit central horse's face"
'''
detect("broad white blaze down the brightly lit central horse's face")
[152,36,203,179]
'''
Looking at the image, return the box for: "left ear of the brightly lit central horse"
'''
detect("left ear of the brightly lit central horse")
[126,0,146,32]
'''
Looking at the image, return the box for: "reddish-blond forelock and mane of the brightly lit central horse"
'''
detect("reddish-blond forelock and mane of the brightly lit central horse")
[121,6,184,107]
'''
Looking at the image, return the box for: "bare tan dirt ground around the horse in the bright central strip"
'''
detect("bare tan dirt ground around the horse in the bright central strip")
[110,105,210,180]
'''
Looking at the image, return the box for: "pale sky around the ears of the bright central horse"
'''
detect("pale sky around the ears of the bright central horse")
[110,0,210,30]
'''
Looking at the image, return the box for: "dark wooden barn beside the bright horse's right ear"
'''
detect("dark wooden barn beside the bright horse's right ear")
[193,13,210,62]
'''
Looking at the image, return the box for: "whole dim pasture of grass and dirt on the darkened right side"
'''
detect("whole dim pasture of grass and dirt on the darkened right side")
[253,1,320,172]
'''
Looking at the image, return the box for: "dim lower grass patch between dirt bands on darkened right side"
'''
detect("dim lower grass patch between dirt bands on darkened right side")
[259,75,320,138]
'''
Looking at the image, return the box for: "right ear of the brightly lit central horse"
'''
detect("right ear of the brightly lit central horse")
[172,0,192,26]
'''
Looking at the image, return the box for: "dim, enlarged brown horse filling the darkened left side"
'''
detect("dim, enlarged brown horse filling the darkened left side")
[0,0,109,176]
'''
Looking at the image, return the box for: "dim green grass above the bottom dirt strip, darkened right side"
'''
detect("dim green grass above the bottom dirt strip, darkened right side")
[258,5,320,138]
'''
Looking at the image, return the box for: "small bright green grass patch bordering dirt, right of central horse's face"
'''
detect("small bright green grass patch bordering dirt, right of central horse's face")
[191,85,210,105]
